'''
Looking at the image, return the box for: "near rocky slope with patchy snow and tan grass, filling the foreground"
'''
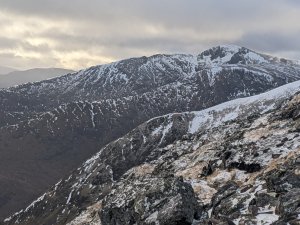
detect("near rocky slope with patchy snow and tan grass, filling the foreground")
[4,81,300,225]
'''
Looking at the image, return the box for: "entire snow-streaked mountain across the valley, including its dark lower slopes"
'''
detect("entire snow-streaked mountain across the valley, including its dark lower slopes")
[0,45,300,218]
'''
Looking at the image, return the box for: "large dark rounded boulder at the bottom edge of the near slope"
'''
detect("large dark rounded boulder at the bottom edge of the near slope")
[100,178,202,225]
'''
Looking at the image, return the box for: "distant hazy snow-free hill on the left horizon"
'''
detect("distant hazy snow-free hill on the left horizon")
[0,68,74,88]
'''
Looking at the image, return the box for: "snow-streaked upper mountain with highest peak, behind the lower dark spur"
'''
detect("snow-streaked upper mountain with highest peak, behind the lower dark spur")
[0,45,300,125]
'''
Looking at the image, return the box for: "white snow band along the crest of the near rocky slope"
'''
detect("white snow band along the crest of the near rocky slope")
[79,78,300,172]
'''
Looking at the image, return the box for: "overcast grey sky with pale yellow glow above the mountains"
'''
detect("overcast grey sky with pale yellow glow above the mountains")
[0,0,300,69]
